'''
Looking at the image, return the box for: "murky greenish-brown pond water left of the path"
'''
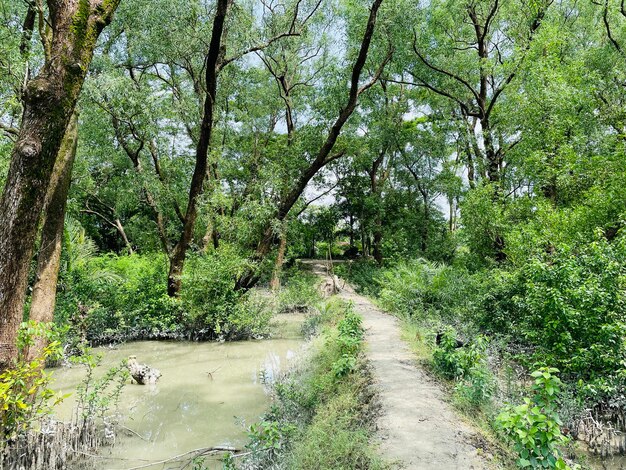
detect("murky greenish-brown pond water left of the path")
[54,316,303,469]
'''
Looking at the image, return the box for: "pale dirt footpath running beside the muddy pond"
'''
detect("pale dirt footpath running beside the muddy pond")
[307,262,492,470]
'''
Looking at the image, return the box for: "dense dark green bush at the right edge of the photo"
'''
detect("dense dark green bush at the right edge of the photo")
[517,238,626,380]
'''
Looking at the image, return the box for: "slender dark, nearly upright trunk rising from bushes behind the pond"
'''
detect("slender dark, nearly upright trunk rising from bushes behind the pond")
[167,0,232,297]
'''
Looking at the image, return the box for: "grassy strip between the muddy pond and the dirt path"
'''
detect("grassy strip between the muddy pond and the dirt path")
[239,299,387,470]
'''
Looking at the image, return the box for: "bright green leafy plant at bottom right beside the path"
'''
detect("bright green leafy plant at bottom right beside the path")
[496,367,570,470]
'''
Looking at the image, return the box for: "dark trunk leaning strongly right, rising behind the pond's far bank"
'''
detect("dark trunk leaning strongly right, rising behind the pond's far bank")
[235,0,391,289]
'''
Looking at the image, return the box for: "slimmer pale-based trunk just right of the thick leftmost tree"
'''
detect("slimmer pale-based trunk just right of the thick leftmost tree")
[26,113,78,361]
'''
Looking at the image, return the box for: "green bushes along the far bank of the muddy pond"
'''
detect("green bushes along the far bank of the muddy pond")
[55,245,271,344]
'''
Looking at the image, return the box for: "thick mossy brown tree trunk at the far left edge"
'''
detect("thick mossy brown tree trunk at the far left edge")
[0,0,120,370]
